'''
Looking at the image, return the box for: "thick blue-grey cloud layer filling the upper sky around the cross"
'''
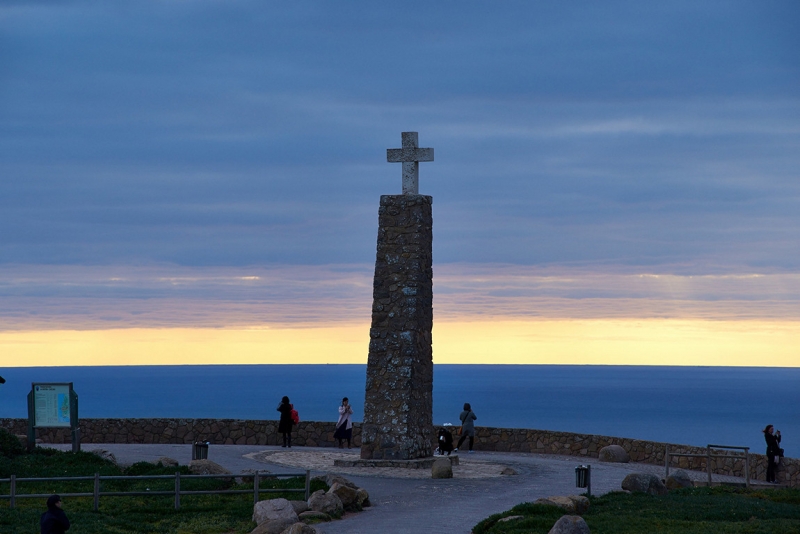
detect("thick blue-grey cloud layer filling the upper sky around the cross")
[0,2,800,273]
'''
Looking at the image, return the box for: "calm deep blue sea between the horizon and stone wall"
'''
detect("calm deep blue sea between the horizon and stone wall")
[0,365,800,457]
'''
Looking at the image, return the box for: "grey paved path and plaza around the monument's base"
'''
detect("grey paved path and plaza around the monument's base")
[47,444,752,534]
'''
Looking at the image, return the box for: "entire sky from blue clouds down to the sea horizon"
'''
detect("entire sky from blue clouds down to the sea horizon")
[0,0,800,368]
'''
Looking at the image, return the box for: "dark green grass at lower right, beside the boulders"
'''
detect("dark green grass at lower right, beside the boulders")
[473,486,800,534]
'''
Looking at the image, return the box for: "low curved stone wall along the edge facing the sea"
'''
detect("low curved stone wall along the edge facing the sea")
[0,419,800,487]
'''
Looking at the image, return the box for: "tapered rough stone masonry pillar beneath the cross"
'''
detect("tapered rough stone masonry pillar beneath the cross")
[361,194,433,460]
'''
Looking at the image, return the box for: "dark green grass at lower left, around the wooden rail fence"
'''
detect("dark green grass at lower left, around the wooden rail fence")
[0,449,327,534]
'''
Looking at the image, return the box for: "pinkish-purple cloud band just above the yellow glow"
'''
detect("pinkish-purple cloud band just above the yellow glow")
[0,264,800,330]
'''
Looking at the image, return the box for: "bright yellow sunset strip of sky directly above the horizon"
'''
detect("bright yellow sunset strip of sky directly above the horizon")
[0,319,800,367]
